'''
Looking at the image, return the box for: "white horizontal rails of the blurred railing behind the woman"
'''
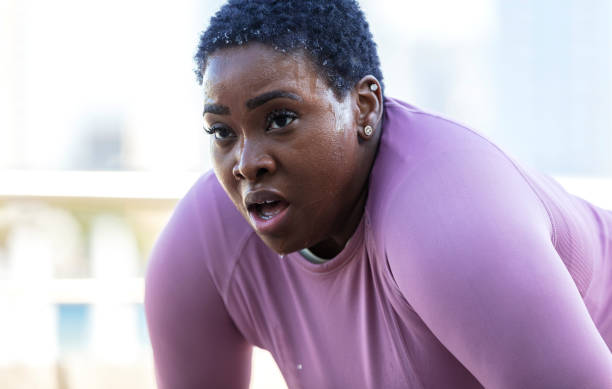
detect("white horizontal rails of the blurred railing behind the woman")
[0,171,612,304]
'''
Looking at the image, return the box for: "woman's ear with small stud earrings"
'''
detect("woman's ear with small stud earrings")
[355,75,383,140]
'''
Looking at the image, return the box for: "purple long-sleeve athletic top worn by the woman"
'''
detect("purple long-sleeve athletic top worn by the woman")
[145,98,612,389]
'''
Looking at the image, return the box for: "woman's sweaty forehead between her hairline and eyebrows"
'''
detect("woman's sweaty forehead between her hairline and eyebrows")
[202,43,328,99]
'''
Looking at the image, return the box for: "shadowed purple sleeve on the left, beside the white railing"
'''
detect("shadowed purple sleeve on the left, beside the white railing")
[145,192,252,389]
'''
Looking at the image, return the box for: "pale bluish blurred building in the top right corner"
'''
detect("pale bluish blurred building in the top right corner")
[492,0,612,176]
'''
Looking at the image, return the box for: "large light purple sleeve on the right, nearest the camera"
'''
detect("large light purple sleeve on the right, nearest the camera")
[385,150,612,389]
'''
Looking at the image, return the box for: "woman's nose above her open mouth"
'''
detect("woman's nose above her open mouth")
[232,140,276,181]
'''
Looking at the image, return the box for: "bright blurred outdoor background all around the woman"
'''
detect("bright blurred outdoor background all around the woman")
[0,0,612,389]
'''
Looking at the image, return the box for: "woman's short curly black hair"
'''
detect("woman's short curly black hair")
[195,0,383,97]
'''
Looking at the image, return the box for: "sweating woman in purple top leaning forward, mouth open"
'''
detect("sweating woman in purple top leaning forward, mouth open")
[146,0,612,389]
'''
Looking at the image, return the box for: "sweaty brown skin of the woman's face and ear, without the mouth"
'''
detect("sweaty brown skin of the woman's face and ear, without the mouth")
[202,43,383,258]
